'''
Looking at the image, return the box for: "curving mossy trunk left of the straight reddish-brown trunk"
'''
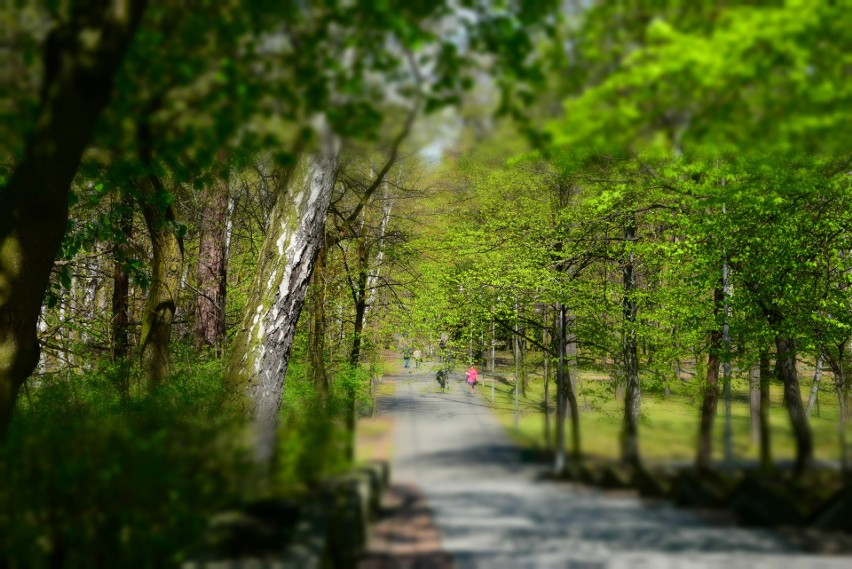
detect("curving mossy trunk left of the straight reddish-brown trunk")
[139,174,183,389]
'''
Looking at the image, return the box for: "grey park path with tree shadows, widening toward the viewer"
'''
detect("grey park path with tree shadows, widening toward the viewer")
[363,365,852,569]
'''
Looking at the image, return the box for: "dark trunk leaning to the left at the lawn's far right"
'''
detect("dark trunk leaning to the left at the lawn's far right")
[775,332,814,477]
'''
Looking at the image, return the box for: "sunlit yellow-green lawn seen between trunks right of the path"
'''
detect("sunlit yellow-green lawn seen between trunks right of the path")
[480,356,840,462]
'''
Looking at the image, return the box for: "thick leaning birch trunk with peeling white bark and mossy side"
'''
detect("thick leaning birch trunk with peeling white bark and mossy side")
[226,128,339,465]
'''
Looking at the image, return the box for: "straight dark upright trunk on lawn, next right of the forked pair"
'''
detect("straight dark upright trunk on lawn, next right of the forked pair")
[621,218,641,467]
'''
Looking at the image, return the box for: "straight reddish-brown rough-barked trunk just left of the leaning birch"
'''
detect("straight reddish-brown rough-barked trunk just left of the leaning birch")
[195,162,230,358]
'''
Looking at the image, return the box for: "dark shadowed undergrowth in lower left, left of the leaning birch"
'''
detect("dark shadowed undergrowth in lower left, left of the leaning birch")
[0,360,251,567]
